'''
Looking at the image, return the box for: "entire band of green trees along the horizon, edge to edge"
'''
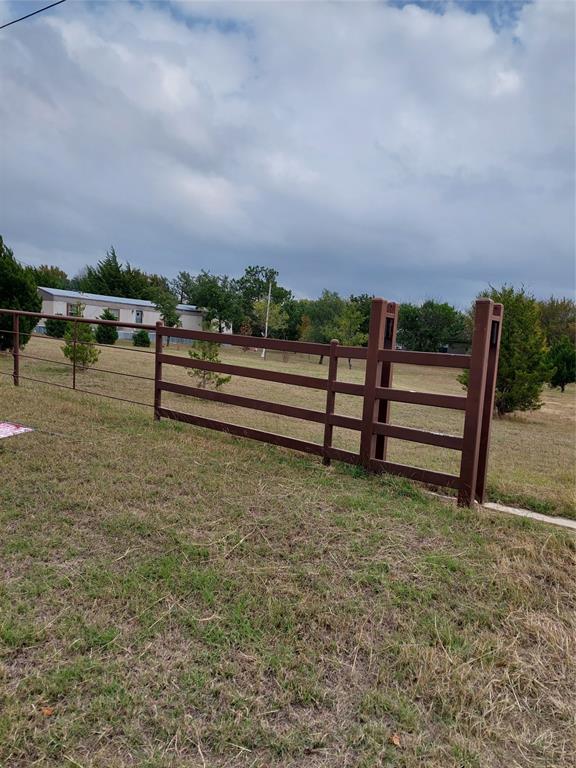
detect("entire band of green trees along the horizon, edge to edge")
[0,237,576,414]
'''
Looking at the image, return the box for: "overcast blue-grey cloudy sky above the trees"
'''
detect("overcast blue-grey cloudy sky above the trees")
[0,0,575,305]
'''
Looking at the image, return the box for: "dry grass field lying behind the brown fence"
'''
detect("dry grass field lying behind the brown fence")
[0,339,576,517]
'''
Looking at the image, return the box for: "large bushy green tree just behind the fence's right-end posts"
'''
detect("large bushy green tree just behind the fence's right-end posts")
[459,285,554,416]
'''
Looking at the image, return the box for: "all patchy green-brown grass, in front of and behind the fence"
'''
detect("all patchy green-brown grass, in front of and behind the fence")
[0,341,576,768]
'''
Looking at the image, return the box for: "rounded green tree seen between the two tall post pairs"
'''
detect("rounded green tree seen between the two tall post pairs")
[397,299,469,352]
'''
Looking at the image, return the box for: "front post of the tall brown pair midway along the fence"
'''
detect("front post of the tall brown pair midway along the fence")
[360,299,388,469]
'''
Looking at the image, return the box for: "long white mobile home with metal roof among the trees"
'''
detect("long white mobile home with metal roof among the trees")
[38,288,203,338]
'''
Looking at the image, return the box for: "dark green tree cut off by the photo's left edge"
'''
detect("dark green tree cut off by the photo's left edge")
[0,235,42,351]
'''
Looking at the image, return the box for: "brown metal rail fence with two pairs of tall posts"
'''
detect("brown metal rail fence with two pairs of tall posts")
[0,299,503,506]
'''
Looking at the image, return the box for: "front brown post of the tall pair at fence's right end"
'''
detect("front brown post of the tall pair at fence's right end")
[458,299,494,507]
